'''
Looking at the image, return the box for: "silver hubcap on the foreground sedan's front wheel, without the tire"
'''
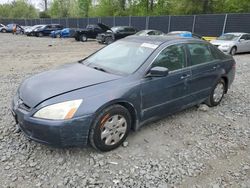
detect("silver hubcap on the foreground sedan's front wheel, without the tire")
[101,115,127,145]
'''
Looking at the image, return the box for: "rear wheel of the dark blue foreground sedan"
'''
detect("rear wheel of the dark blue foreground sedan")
[206,79,226,107]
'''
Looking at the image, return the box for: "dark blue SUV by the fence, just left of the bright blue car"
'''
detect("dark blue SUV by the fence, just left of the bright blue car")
[33,24,63,37]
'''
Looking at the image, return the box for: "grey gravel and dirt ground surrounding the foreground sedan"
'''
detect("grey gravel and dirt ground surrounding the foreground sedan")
[0,34,250,188]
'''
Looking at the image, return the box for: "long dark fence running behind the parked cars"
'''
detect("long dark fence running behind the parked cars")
[0,13,250,36]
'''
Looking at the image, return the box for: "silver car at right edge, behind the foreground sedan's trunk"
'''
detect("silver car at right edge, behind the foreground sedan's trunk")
[210,33,250,55]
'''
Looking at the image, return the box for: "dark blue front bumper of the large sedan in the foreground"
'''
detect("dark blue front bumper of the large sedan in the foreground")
[12,101,92,147]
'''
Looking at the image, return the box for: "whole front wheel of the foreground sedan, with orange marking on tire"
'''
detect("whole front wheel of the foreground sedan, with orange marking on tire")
[89,105,131,151]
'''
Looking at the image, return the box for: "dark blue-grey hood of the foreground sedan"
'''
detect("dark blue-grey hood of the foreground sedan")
[18,63,121,107]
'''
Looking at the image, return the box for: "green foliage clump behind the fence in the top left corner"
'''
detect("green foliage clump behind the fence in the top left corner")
[0,0,38,18]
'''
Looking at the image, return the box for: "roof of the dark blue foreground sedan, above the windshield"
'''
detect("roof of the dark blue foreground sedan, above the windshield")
[121,35,201,45]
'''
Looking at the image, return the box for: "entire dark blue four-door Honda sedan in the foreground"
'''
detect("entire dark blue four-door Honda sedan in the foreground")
[12,36,235,151]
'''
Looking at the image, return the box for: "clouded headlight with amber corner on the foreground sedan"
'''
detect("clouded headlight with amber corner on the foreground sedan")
[34,99,82,120]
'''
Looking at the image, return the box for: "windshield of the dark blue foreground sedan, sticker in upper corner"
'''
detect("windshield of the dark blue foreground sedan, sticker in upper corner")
[83,41,157,74]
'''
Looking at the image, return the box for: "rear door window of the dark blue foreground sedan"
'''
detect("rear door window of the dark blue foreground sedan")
[187,43,216,66]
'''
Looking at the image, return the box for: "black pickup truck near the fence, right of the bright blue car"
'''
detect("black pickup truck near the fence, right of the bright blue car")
[75,23,110,42]
